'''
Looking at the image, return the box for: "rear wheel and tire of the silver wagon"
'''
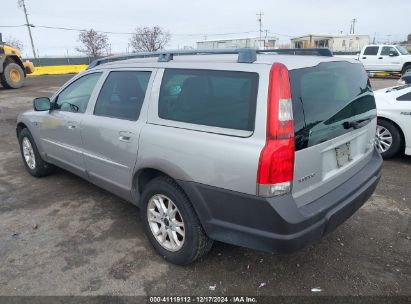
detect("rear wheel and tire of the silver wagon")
[140,176,213,265]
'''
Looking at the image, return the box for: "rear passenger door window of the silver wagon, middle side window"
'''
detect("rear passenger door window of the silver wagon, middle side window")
[94,71,151,120]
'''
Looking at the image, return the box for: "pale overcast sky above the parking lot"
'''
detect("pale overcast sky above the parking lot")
[0,0,411,57]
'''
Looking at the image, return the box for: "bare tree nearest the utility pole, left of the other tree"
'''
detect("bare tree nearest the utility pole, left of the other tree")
[76,29,110,57]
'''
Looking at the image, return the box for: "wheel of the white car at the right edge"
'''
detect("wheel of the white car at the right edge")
[375,119,402,159]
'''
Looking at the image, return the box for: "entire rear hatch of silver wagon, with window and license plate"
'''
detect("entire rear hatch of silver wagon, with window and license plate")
[289,61,376,207]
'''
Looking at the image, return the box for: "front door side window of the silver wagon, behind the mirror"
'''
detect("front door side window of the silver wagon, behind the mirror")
[54,73,101,113]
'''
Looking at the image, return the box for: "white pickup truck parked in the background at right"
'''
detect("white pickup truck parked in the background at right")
[358,45,411,74]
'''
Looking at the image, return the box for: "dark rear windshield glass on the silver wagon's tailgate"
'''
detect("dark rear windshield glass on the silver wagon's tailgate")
[290,61,377,151]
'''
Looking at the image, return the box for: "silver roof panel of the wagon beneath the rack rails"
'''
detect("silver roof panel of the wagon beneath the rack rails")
[91,54,360,70]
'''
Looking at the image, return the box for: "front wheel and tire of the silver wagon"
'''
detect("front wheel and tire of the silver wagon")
[19,128,54,177]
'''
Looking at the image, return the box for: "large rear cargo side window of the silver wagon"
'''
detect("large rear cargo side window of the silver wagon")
[158,69,258,131]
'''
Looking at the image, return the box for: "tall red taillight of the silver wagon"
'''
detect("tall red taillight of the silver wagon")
[257,63,295,197]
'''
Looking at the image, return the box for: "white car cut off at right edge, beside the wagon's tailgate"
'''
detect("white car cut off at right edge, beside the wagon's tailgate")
[374,85,411,159]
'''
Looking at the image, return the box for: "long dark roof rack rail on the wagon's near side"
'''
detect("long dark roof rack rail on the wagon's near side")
[87,48,333,69]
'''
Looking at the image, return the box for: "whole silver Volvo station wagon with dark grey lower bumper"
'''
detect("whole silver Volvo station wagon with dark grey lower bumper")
[17,49,382,264]
